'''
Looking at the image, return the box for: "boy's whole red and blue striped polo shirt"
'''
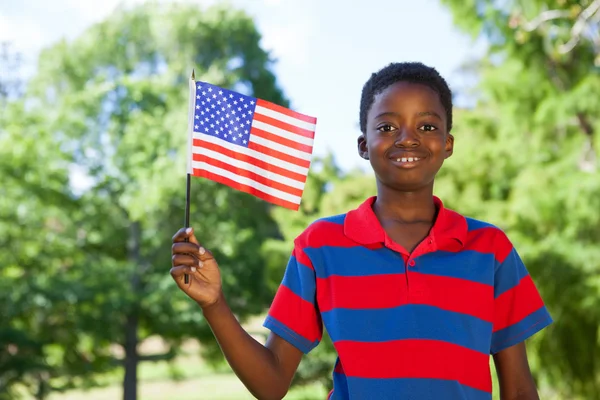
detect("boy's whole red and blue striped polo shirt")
[264,197,552,400]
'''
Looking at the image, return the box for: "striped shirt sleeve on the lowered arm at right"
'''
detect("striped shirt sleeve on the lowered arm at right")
[491,235,552,354]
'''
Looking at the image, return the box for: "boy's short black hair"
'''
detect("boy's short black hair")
[360,62,452,133]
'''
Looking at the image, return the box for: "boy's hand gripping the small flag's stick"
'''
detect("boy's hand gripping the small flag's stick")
[171,228,222,309]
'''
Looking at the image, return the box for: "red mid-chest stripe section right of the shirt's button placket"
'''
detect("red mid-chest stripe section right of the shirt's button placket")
[408,272,494,322]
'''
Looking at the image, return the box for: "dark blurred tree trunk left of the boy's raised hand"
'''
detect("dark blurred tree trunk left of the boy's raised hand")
[123,222,142,400]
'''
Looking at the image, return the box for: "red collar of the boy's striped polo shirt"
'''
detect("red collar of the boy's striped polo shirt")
[344,196,468,246]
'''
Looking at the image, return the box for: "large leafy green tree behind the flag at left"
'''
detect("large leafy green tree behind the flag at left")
[0,4,287,400]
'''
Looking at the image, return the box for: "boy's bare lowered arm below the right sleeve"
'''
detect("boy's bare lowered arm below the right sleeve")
[494,342,539,400]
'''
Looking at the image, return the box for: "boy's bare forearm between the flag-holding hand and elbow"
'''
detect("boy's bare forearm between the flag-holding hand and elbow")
[203,298,289,400]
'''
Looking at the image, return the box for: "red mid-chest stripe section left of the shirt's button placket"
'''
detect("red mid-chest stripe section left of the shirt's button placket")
[317,274,407,312]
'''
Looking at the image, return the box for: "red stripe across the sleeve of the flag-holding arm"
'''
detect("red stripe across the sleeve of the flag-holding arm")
[269,285,323,342]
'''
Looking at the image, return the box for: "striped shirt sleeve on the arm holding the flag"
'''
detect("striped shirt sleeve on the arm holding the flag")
[263,241,323,354]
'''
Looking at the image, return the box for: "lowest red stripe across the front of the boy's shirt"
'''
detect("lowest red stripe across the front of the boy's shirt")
[335,340,492,393]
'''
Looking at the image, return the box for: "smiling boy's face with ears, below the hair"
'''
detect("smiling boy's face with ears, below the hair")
[358,82,454,191]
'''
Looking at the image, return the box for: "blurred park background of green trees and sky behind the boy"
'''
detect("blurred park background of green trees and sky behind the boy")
[0,0,600,400]
